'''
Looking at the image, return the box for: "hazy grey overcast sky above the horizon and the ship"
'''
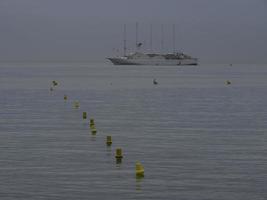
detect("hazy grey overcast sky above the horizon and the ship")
[0,0,267,63]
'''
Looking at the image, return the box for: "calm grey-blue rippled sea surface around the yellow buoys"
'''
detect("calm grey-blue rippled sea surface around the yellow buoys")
[0,62,267,200]
